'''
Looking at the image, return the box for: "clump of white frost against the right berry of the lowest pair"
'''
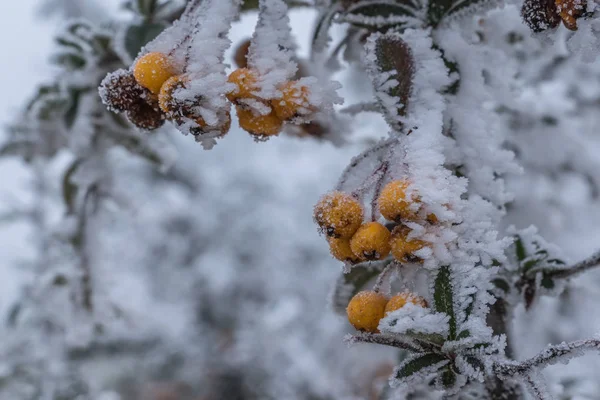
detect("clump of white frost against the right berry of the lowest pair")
[379,302,449,336]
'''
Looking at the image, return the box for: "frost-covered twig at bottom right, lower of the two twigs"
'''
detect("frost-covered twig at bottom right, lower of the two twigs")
[494,339,600,377]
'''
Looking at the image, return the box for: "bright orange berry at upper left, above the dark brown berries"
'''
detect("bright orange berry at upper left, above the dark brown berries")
[133,52,177,94]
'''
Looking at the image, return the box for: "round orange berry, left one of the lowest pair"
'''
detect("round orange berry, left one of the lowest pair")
[346,290,388,333]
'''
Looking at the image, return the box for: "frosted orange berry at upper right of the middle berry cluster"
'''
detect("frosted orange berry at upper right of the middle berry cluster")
[377,180,419,222]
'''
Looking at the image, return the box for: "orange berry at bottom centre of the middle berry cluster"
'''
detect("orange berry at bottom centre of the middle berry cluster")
[350,222,391,261]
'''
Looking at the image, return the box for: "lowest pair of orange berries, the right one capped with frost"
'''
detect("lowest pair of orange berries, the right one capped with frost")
[346,290,427,333]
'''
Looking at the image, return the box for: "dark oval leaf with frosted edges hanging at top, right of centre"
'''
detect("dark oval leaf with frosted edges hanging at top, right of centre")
[372,33,415,131]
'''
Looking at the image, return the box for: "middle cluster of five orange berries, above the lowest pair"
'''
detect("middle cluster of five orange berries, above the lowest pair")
[314,180,438,264]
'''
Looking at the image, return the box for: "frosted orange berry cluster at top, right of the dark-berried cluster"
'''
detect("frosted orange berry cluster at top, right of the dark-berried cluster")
[227,68,316,139]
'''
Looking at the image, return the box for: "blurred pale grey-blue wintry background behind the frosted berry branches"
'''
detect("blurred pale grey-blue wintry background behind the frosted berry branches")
[0,0,600,400]
